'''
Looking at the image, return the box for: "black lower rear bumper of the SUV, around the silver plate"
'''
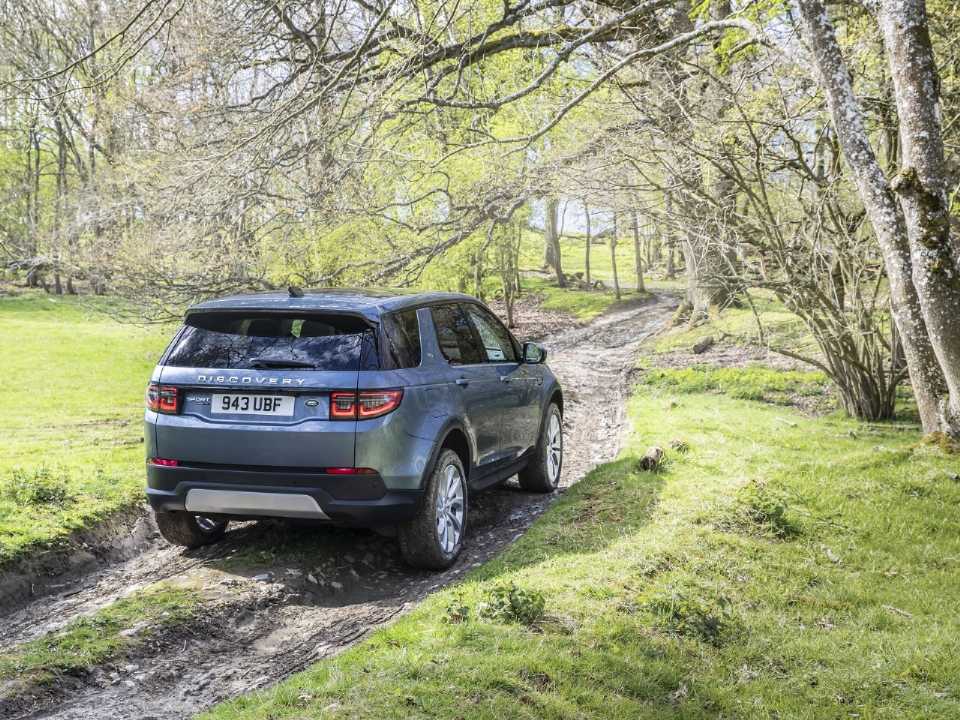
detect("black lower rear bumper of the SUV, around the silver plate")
[147,463,423,527]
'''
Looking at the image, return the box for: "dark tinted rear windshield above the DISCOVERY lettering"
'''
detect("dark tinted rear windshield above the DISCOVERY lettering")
[166,313,377,371]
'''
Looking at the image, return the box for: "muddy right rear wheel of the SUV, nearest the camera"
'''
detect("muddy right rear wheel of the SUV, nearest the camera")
[397,449,467,570]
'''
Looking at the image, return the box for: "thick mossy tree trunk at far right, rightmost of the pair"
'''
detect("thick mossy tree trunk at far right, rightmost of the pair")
[880,0,960,436]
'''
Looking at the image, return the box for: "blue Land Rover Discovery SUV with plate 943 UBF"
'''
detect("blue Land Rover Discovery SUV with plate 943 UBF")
[145,288,563,569]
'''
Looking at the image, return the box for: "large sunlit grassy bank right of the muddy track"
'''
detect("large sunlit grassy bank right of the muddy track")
[205,376,960,720]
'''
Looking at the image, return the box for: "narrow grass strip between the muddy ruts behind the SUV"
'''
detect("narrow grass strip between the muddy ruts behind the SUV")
[0,584,200,686]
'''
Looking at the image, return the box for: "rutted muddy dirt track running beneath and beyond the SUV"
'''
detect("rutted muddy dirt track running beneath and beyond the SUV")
[0,295,676,720]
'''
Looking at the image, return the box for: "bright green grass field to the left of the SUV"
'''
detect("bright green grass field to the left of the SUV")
[0,293,169,565]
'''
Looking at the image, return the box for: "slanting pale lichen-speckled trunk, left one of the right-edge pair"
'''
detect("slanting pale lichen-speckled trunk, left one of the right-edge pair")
[797,0,945,432]
